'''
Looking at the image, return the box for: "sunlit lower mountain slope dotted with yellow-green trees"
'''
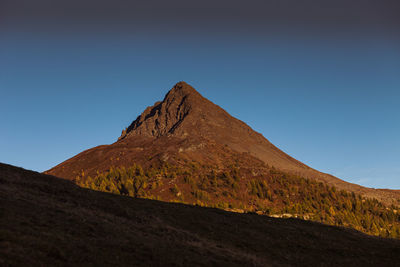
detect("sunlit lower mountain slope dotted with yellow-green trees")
[76,162,400,238]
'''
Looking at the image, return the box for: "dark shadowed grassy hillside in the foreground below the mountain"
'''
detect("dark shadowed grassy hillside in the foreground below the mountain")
[0,164,400,266]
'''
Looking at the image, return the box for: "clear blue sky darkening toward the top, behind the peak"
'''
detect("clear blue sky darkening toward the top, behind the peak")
[0,0,400,189]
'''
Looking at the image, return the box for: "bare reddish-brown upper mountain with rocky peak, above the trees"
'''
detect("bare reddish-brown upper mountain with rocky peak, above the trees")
[47,82,400,203]
